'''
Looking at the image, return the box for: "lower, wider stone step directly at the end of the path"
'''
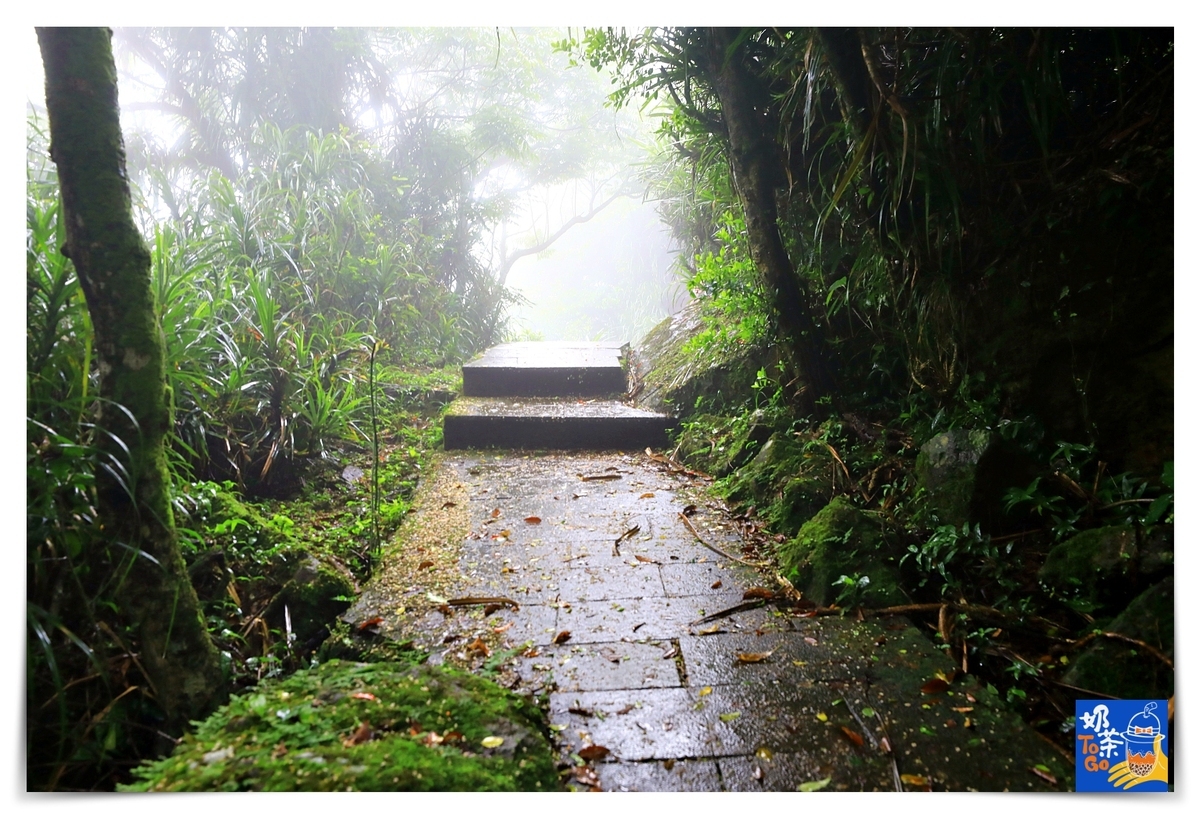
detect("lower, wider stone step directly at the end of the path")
[443,397,671,450]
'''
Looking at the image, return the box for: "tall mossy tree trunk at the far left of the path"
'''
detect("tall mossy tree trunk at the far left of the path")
[37,28,224,729]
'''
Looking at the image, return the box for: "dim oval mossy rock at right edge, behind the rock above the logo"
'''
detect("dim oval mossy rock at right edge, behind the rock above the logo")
[1038,525,1175,606]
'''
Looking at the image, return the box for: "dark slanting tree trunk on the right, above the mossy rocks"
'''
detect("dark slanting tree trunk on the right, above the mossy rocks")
[706,29,834,409]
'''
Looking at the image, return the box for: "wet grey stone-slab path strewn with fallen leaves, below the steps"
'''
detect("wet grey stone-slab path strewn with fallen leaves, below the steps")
[391,451,1069,792]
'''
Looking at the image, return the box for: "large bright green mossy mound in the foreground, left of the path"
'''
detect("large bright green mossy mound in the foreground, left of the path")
[125,661,559,792]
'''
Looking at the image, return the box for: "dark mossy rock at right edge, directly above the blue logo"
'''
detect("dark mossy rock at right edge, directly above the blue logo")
[1063,577,1175,699]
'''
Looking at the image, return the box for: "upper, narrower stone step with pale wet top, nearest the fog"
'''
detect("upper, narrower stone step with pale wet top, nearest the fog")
[462,341,628,397]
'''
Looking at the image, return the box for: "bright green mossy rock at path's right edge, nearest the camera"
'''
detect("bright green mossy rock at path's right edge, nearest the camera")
[779,497,907,607]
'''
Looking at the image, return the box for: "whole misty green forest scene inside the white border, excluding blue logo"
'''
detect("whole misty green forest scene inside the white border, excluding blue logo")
[24,28,1175,792]
